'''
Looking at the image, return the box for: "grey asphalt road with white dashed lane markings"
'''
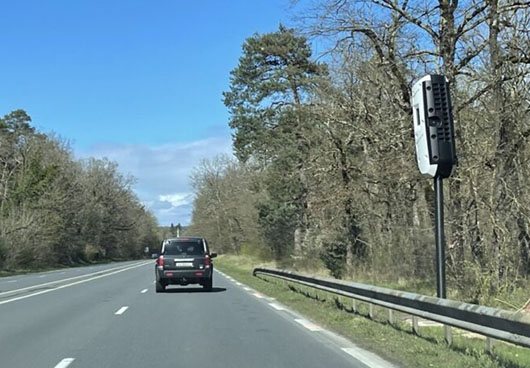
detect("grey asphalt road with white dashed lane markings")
[0,260,392,368]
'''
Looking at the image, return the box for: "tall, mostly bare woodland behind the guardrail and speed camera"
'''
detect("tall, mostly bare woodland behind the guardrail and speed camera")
[191,0,530,301]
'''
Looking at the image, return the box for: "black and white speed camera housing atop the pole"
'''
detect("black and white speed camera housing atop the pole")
[412,74,457,178]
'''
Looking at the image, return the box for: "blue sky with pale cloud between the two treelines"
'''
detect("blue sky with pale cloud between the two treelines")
[0,0,291,225]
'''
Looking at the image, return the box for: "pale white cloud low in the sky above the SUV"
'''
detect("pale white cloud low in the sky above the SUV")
[77,137,232,225]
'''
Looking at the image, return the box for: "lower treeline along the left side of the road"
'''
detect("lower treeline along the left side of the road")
[0,110,159,269]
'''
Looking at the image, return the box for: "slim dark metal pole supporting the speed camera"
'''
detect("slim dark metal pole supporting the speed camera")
[434,176,446,299]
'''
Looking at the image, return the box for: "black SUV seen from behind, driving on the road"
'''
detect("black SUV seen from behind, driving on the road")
[155,237,217,293]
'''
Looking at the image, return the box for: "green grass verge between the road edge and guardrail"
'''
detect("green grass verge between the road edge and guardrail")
[215,255,530,368]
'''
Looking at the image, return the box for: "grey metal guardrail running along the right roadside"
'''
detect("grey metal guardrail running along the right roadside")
[253,268,530,349]
